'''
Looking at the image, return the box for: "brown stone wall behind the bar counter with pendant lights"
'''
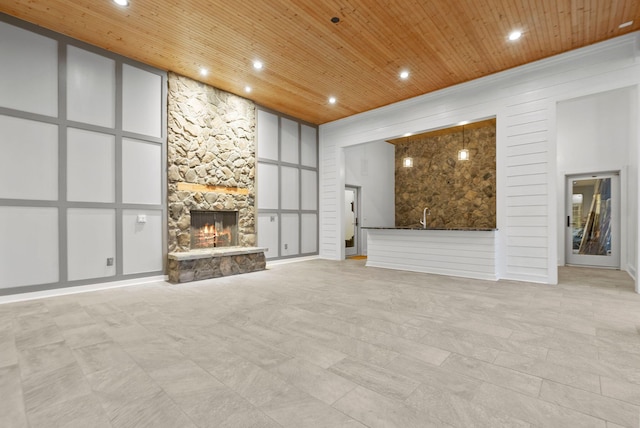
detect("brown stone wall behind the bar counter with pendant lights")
[395,120,496,228]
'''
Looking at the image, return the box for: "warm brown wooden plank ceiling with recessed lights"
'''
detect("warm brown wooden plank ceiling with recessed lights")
[0,0,640,124]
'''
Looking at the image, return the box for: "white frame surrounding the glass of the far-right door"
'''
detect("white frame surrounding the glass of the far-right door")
[563,170,626,269]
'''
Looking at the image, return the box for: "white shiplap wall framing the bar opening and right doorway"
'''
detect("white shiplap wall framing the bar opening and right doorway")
[319,33,640,284]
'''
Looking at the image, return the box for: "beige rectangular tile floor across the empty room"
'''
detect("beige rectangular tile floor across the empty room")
[0,260,640,428]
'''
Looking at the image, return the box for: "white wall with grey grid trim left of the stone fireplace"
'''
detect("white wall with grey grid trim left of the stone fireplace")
[0,14,167,295]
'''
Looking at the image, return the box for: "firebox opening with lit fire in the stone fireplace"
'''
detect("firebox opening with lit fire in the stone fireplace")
[190,211,238,250]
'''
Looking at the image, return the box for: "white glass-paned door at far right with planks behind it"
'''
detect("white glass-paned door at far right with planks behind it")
[565,173,620,268]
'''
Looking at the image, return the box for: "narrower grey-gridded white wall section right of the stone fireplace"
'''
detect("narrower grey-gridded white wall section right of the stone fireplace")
[256,106,319,260]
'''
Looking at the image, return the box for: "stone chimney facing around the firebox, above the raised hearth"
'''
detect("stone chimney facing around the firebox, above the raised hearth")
[167,73,256,252]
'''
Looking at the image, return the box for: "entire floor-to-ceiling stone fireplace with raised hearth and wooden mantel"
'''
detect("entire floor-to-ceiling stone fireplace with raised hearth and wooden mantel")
[167,73,265,282]
